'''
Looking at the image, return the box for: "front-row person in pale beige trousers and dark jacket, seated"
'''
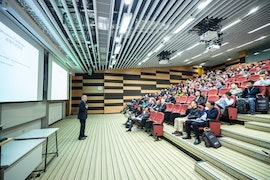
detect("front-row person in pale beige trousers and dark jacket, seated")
[172,101,201,136]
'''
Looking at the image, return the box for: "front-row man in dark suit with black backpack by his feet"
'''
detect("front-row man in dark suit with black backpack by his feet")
[183,101,218,145]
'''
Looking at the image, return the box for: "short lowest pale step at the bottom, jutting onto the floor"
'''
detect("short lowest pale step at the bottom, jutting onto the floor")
[195,161,235,180]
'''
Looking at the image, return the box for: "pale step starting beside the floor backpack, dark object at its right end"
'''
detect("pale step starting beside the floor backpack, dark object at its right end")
[220,137,270,163]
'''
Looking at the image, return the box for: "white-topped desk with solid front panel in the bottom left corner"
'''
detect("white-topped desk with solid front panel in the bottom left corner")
[1,139,44,180]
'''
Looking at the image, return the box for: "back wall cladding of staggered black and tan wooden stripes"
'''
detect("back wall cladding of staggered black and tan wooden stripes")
[71,67,198,114]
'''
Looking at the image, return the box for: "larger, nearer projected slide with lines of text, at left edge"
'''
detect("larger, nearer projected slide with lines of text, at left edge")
[0,22,39,102]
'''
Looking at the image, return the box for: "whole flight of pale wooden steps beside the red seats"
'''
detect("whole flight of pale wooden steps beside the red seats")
[164,114,270,179]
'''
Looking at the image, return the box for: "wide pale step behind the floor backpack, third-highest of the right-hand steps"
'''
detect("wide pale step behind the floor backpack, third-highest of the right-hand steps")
[221,124,270,149]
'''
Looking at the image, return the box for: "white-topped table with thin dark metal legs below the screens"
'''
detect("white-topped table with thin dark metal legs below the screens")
[14,128,59,172]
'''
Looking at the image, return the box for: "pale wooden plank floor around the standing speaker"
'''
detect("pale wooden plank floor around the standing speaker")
[33,114,203,180]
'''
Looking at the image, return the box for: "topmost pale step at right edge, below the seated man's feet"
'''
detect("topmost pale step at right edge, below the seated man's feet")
[237,113,270,124]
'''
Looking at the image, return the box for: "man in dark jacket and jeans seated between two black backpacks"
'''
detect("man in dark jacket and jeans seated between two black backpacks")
[237,80,260,115]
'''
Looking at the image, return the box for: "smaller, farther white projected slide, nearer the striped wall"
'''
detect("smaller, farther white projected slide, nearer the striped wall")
[49,61,68,100]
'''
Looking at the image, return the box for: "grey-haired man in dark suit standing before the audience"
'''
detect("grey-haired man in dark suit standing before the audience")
[78,95,88,140]
